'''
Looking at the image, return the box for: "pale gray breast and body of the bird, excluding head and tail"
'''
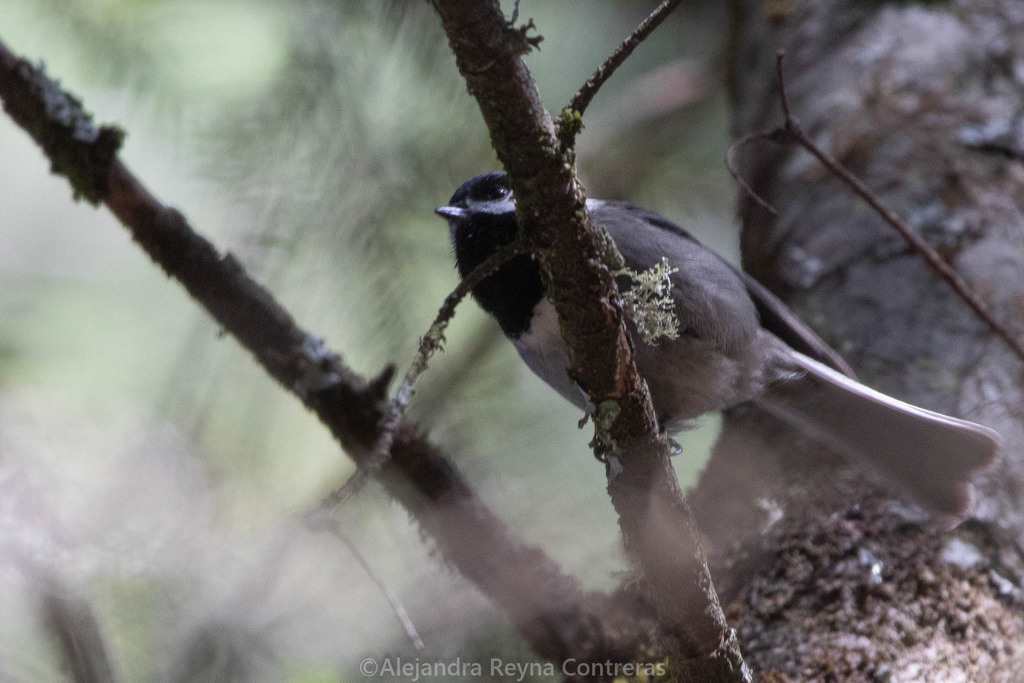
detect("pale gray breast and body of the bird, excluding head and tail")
[512,201,774,430]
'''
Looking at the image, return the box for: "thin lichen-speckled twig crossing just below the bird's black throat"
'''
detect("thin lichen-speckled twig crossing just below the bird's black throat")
[319,242,525,501]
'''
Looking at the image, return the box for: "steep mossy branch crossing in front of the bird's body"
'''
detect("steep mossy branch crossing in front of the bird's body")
[432,0,742,680]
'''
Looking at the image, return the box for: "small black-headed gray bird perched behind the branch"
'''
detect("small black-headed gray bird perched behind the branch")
[435,172,1001,520]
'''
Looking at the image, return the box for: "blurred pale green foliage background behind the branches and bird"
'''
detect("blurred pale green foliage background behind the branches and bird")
[0,0,735,682]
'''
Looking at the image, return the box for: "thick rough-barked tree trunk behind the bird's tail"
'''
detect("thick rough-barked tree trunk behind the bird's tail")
[691,0,1024,681]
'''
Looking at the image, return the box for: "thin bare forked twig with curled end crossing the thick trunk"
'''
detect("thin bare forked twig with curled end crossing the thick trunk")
[726,50,1024,368]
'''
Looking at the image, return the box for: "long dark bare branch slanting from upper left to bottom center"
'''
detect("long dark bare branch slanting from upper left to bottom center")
[0,38,651,661]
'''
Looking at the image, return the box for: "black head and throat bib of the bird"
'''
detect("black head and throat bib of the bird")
[435,172,544,338]
